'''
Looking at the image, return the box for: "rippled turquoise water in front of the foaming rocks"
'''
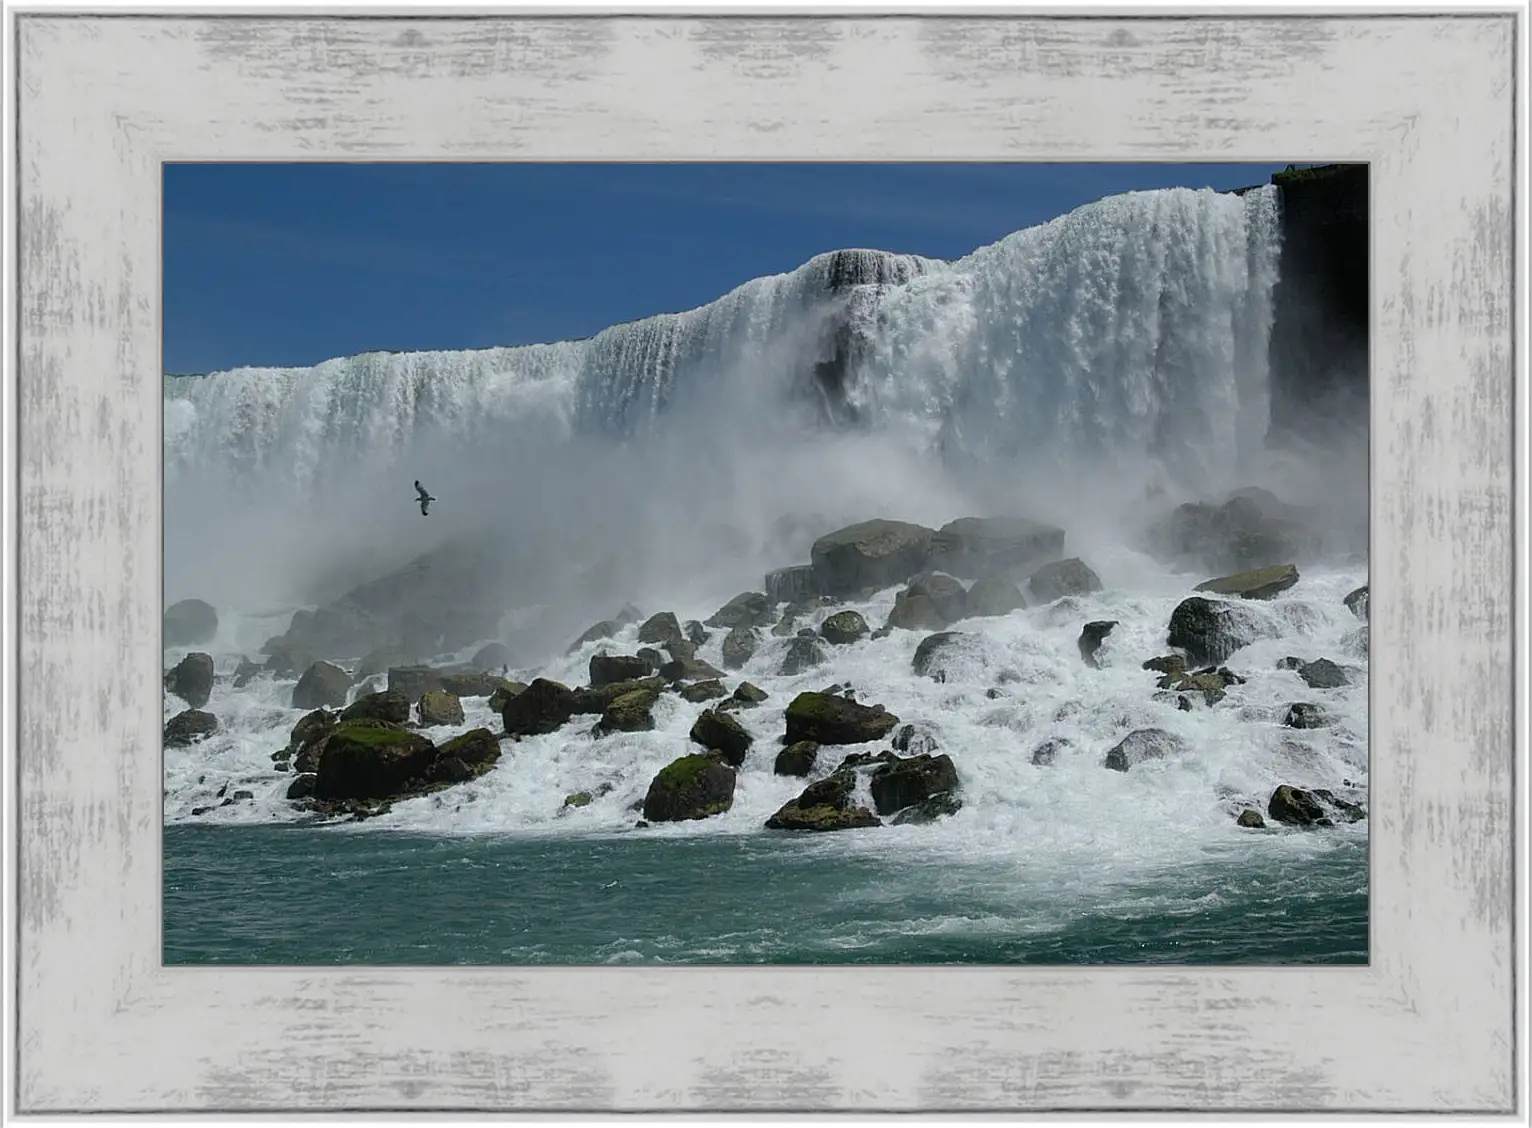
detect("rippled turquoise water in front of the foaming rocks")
[164,826,1368,964]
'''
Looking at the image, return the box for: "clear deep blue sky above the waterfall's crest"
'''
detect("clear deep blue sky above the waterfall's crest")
[164,164,1282,372]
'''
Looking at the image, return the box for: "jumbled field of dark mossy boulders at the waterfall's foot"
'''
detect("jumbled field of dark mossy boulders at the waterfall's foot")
[164,490,1368,832]
